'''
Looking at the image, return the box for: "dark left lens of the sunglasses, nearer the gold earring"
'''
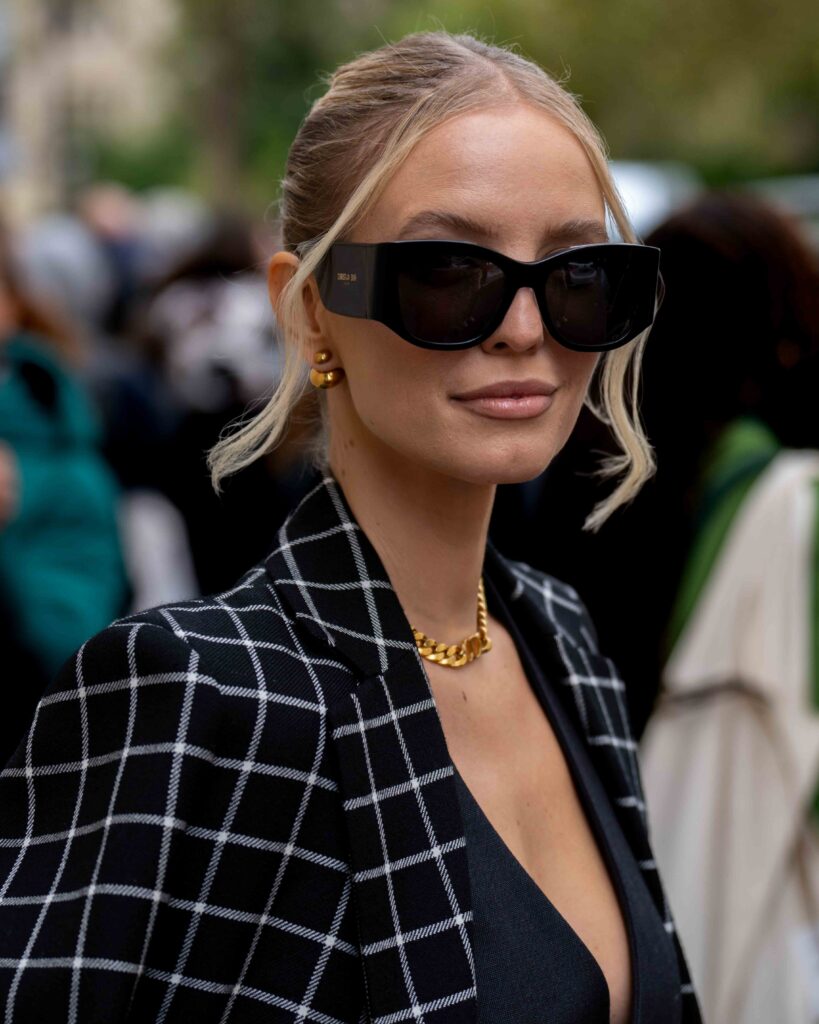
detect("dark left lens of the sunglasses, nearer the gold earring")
[397,250,505,344]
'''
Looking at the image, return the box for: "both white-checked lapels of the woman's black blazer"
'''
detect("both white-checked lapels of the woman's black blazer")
[266,474,661,1024]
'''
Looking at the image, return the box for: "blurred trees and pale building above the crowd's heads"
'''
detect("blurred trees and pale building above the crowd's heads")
[0,0,819,224]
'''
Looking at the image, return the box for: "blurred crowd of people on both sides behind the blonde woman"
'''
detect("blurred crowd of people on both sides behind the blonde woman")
[0,183,819,1022]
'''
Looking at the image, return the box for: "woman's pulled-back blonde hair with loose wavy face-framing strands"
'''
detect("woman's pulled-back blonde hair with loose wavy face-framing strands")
[208,31,655,530]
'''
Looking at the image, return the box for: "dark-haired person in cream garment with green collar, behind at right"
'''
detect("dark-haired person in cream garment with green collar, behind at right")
[641,193,819,1024]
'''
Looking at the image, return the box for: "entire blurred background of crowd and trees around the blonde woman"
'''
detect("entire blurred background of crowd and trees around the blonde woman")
[0,0,819,1024]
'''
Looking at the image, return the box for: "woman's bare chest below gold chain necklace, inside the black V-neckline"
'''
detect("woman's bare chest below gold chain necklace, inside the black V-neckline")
[428,630,632,1022]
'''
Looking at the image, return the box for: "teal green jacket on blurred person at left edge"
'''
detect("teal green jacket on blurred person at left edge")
[0,334,129,677]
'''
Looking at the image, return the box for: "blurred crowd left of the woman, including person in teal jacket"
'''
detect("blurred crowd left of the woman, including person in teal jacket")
[0,183,323,762]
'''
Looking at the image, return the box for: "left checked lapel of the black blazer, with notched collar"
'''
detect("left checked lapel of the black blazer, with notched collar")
[267,475,477,1024]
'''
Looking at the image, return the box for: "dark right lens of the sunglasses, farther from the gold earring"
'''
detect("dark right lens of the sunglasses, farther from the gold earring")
[546,250,655,348]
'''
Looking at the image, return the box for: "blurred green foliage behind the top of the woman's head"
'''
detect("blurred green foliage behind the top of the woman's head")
[89,0,819,209]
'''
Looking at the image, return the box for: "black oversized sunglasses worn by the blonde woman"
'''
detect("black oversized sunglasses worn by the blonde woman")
[315,239,662,352]
